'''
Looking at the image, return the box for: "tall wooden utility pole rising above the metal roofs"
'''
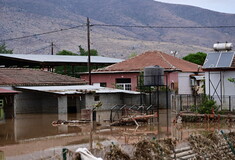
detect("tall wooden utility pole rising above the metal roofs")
[87,17,91,85]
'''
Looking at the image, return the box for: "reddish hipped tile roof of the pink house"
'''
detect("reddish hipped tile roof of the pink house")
[95,51,201,72]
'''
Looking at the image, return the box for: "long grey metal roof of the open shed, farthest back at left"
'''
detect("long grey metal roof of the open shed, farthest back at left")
[0,54,123,64]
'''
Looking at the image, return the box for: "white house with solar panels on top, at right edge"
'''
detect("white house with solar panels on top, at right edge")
[203,51,235,110]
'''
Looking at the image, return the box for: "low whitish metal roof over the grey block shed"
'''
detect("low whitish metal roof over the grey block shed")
[16,85,140,95]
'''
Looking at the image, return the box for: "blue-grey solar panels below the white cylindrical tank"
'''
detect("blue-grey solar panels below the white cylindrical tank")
[203,52,234,68]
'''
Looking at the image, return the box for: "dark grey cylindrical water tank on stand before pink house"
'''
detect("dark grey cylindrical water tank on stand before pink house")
[144,66,164,86]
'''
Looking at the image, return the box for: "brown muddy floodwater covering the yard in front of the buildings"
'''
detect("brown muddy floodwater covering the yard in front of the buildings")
[0,110,235,159]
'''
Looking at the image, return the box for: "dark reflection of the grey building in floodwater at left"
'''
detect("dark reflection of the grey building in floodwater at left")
[0,114,81,146]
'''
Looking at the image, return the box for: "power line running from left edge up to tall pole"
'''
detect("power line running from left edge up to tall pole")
[0,25,85,42]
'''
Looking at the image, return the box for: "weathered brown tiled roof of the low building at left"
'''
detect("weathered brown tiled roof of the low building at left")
[0,68,85,86]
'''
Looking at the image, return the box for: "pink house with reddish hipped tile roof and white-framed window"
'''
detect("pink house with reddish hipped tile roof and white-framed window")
[81,51,204,94]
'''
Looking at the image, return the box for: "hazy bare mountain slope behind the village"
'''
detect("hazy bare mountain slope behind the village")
[0,0,235,58]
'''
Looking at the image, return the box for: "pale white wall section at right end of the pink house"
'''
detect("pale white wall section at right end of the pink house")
[178,72,194,94]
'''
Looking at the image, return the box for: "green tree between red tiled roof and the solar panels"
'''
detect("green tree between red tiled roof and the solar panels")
[183,52,207,65]
